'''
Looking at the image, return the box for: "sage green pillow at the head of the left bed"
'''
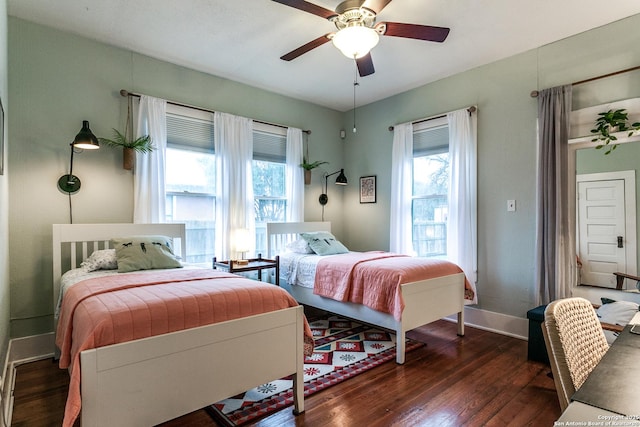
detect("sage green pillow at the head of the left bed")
[111,236,182,273]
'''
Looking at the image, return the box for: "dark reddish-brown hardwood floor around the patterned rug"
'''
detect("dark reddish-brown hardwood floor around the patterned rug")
[12,320,560,427]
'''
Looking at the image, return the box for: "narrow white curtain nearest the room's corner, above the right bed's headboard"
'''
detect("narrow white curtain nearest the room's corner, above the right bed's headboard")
[285,128,304,222]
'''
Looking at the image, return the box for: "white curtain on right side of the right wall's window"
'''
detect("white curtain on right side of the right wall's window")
[447,109,478,304]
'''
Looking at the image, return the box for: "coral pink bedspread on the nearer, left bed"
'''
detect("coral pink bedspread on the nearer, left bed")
[56,269,312,426]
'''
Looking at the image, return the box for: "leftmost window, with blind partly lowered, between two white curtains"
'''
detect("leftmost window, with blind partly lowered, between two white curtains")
[165,105,216,264]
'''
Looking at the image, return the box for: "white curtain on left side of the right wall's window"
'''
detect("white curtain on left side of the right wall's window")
[389,123,414,255]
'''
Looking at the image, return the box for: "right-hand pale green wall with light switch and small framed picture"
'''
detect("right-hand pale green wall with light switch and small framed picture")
[344,15,640,317]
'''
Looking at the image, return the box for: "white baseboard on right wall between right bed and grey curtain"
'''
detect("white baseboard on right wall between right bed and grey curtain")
[446,307,529,341]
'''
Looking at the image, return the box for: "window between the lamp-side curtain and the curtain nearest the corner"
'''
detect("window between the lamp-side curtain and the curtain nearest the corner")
[252,123,287,254]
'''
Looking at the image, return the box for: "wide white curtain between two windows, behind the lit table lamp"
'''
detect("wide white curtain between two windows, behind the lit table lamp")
[214,112,255,259]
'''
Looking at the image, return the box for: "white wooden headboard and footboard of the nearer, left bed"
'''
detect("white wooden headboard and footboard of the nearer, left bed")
[53,224,305,426]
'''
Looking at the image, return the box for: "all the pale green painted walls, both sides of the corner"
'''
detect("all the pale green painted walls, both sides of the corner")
[7,15,640,337]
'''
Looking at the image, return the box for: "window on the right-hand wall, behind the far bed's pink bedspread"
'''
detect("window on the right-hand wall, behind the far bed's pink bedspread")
[411,118,449,257]
